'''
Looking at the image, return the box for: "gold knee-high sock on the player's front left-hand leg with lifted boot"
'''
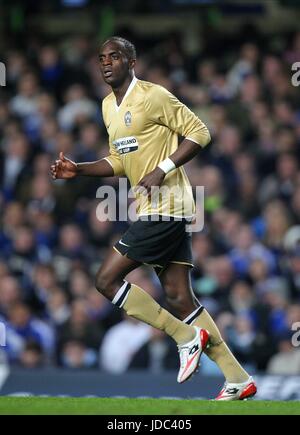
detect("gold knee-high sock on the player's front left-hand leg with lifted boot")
[112,281,195,345]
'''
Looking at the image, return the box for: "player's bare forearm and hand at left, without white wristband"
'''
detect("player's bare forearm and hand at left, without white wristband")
[50,152,114,180]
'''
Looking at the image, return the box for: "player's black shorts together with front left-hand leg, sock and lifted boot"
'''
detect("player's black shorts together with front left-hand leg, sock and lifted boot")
[96,219,209,382]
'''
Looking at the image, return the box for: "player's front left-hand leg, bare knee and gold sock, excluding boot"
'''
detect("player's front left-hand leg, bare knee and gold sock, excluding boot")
[95,248,195,345]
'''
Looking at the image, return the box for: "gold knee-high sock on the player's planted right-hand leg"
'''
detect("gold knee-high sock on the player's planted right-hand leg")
[184,307,249,383]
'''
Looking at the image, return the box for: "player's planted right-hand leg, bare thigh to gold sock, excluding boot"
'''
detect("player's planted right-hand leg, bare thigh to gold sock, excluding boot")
[159,263,249,383]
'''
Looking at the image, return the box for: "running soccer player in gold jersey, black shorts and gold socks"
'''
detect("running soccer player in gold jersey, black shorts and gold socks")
[51,37,256,400]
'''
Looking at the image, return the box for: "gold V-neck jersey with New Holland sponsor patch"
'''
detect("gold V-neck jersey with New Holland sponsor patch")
[102,78,210,217]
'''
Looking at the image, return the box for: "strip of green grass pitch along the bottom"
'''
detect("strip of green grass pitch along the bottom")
[0,397,300,415]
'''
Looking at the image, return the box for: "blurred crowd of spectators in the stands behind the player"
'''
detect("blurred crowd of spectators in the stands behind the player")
[0,26,300,374]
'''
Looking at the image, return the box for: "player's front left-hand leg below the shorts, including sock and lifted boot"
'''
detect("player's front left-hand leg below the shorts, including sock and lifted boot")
[95,249,209,383]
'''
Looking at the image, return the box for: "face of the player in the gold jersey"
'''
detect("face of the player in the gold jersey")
[99,42,135,88]
